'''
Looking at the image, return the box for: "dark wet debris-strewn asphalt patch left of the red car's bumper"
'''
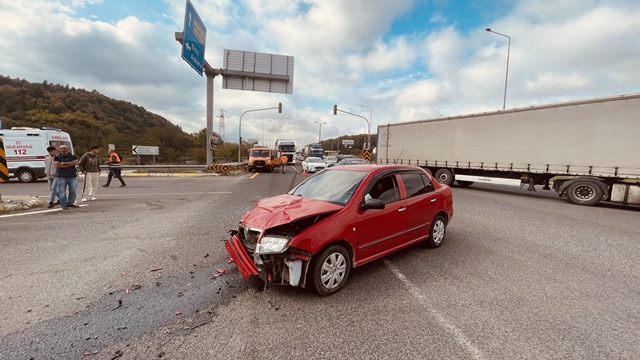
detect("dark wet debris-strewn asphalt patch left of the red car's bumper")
[0,264,250,359]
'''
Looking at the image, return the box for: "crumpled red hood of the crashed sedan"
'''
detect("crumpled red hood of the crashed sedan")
[242,194,343,229]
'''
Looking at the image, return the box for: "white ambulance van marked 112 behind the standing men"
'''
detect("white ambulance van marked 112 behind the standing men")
[0,127,73,183]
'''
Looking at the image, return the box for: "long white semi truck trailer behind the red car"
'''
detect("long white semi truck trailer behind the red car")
[377,94,640,205]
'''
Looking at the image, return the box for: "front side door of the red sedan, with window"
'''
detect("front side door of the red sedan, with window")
[356,174,407,263]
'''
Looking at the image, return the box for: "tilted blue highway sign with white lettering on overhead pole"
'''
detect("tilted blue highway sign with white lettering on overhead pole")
[182,0,207,76]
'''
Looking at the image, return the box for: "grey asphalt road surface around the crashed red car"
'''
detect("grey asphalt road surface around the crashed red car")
[0,171,640,359]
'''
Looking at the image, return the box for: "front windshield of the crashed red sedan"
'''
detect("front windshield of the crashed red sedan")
[289,170,367,206]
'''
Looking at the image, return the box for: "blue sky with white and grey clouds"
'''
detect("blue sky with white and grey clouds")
[0,0,640,147]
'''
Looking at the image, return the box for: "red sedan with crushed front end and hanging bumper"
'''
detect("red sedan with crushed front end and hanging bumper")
[225,165,453,295]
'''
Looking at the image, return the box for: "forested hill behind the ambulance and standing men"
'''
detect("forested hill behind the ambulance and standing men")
[0,75,208,164]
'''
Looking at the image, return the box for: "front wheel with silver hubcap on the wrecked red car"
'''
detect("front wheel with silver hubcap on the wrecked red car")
[310,245,351,296]
